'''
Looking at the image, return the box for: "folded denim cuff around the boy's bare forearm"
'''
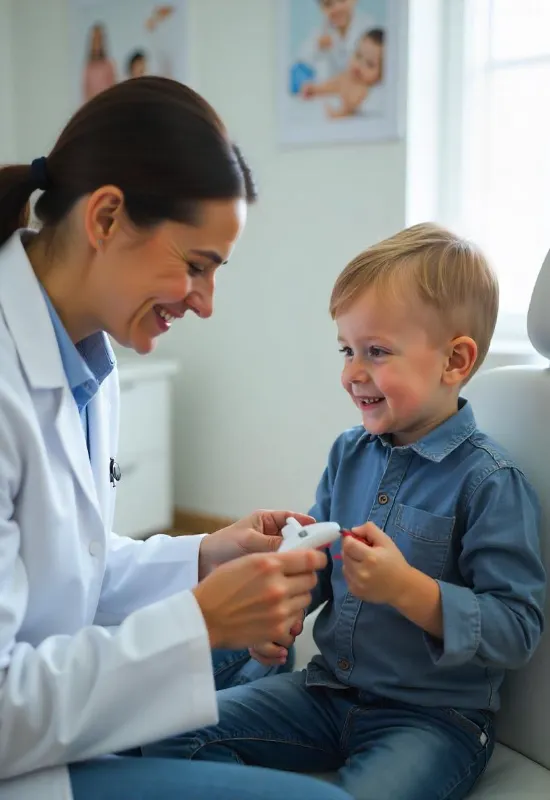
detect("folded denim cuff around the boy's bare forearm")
[424,581,481,667]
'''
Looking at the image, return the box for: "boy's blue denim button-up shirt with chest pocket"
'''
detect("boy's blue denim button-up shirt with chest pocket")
[307,399,545,711]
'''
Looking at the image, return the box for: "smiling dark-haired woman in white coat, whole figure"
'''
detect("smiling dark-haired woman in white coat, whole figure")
[0,78,347,800]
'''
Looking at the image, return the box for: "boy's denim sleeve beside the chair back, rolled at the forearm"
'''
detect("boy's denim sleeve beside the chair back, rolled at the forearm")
[425,467,546,669]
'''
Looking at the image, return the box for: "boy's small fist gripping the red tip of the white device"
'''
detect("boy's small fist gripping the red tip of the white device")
[342,522,412,606]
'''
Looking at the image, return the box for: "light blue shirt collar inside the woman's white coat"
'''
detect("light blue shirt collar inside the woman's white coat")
[41,287,115,444]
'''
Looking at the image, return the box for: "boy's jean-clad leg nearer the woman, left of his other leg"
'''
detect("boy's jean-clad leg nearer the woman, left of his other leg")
[143,672,344,773]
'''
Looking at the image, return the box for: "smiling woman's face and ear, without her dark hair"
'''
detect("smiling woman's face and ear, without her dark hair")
[82,187,247,354]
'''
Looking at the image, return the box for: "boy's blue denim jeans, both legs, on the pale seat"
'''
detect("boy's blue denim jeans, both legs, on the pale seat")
[146,672,494,800]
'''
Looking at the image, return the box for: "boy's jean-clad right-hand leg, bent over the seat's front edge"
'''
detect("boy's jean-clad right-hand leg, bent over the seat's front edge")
[340,704,494,800]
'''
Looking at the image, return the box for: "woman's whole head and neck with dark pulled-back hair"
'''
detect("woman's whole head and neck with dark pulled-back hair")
[18,76,256,354]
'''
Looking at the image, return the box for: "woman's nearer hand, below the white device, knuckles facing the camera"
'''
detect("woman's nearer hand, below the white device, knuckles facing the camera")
[193,550,327,649]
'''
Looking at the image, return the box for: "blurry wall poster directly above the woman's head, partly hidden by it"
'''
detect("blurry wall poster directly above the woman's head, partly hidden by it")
[70,0,188,106]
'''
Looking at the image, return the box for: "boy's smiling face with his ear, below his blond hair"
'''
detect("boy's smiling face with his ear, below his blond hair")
[336,287,476,445]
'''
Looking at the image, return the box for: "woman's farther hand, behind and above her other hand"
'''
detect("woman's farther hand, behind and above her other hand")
[199,511,315,580]
